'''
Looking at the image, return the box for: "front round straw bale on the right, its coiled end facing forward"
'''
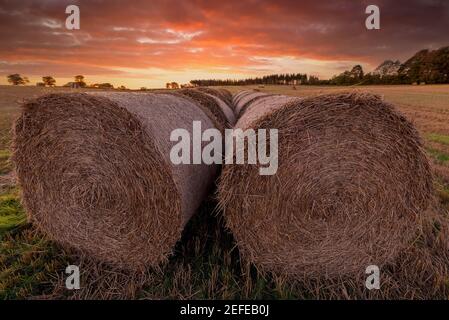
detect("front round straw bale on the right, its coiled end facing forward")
[218,93,432,277]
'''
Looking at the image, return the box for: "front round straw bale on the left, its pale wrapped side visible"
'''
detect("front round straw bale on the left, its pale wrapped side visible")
[12,93,218,270]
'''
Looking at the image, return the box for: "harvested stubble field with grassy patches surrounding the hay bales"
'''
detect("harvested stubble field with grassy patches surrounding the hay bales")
[0,85,449,299]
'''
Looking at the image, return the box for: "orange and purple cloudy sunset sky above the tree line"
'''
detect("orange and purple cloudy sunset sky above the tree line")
[0,0,449,88]
